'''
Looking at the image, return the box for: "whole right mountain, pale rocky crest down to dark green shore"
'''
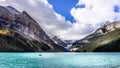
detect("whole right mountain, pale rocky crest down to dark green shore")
[70,21,120,52]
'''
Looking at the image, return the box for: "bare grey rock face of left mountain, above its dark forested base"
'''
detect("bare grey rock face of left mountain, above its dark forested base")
[0,6,64,51]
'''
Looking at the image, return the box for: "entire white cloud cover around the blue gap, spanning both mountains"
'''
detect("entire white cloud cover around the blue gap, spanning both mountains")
[0,0,120,39]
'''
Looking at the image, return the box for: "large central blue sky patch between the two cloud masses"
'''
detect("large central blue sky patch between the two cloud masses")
[48,0,78,22]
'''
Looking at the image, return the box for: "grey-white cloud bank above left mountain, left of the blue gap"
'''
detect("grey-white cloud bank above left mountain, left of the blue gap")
[0,0,73,38]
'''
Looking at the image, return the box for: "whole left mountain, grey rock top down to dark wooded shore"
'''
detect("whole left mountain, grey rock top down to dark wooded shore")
[0,6,65,51]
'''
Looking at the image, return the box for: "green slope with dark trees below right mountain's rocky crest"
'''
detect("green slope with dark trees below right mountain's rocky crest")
[82,29,120,52]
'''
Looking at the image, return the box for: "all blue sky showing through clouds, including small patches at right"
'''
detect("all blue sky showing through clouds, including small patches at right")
[48,0,120,23]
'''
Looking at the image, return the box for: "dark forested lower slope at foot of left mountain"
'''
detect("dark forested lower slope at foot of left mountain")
[0,34,50,52]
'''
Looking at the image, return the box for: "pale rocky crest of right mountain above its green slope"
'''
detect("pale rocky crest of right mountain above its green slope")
[70,21,120,51]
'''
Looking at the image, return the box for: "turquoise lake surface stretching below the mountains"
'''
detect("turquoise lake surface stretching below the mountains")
[0,52,120,68]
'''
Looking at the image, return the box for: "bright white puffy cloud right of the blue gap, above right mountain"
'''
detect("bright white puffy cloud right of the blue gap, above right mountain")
[70,0,120,37]
